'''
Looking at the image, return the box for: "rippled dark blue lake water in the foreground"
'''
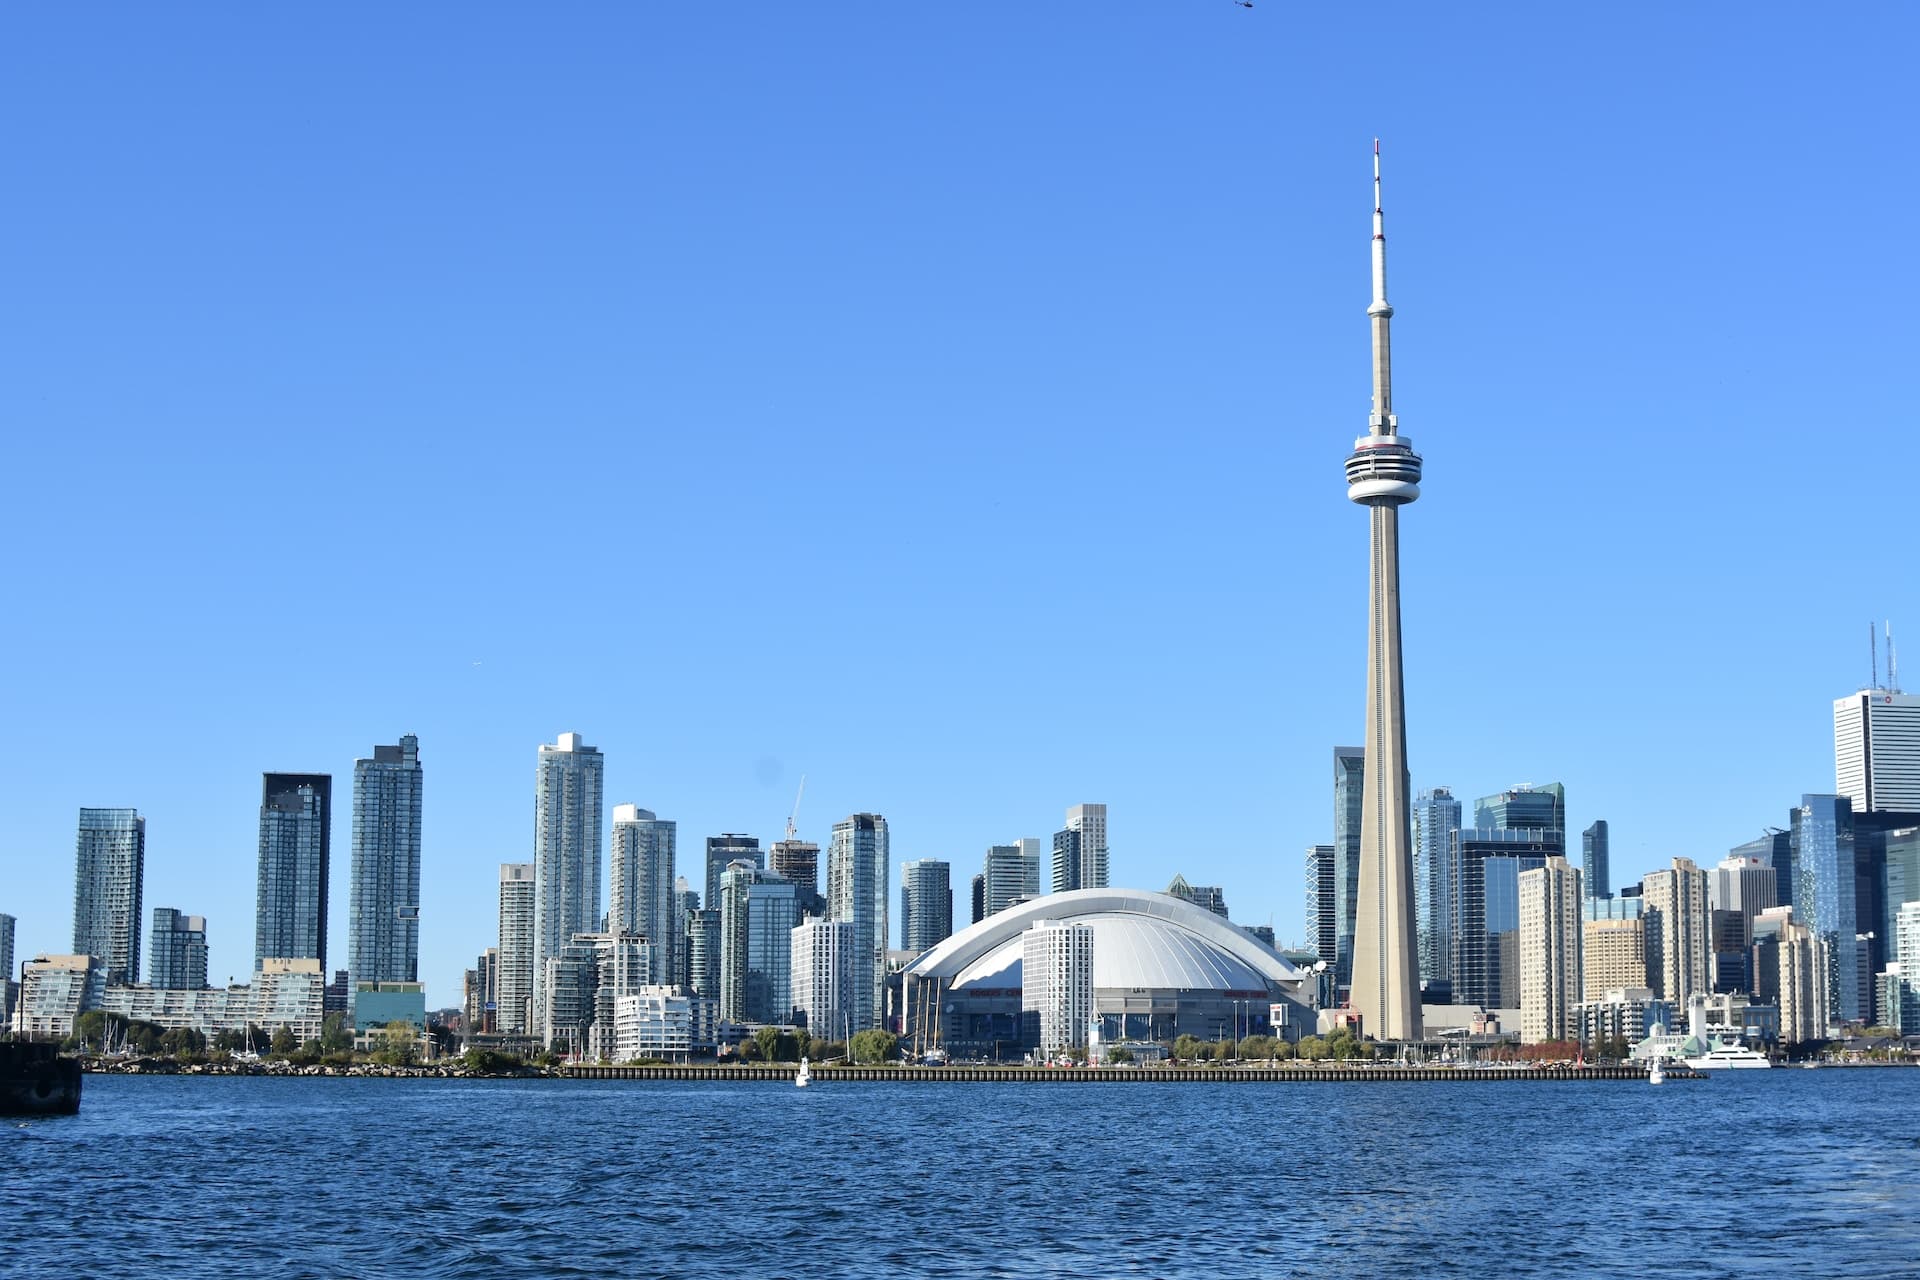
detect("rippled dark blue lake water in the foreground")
[0,1069,1920,1280]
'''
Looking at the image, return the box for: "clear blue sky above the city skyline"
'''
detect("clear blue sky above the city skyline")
[0,0,1920,1004]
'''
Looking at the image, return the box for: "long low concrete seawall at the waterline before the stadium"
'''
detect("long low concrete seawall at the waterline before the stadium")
[559,1063,1705,1084]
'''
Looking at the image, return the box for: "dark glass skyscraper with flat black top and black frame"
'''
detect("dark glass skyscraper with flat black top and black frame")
[253,773,334,973]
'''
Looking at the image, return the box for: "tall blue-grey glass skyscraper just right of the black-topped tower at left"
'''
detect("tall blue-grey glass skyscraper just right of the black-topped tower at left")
[348,733,420,984]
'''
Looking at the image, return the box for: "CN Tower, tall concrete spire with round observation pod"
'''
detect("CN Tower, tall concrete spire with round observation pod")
[1346,140,1421,1040]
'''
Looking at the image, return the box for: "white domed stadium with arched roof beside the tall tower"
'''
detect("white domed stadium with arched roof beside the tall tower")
[900,889,1313,1057]
